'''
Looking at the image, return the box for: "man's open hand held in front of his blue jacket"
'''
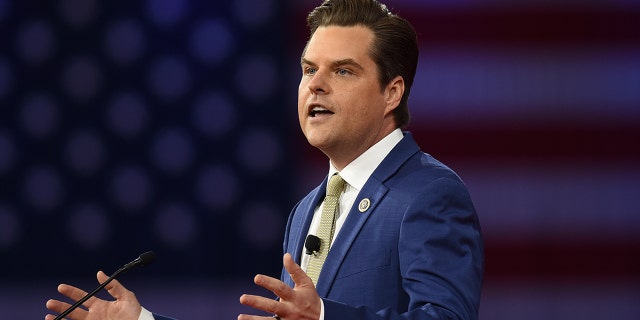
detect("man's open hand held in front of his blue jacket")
[238,253,321,320]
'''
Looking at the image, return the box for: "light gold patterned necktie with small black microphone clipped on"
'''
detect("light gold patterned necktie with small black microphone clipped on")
[307,174,347,285]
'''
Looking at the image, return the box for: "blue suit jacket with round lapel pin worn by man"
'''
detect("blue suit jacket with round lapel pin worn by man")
[281,133,484,320]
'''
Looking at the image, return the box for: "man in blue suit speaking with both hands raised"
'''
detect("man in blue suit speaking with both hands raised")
[47,0,483,320]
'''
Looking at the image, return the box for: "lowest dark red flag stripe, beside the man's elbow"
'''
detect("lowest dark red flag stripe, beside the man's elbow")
[485,238,640,281]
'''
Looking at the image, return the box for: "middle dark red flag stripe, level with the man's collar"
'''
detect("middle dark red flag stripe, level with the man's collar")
[410,123,640,162]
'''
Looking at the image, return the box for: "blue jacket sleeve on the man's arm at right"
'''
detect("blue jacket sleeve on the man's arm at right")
[323,178,483,320]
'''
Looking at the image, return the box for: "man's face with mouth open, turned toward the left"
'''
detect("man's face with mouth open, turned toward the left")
[298,26,397,170]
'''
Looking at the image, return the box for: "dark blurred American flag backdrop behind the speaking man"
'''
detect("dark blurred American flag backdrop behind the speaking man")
[0,0,640,319]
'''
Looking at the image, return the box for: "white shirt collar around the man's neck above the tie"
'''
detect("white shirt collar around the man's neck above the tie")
[329,128,404,190]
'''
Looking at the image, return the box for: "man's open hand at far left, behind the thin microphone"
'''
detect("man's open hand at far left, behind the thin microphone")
[45,271,142,320]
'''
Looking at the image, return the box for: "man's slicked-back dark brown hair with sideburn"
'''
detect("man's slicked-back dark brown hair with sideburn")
[307,0,418,128]
